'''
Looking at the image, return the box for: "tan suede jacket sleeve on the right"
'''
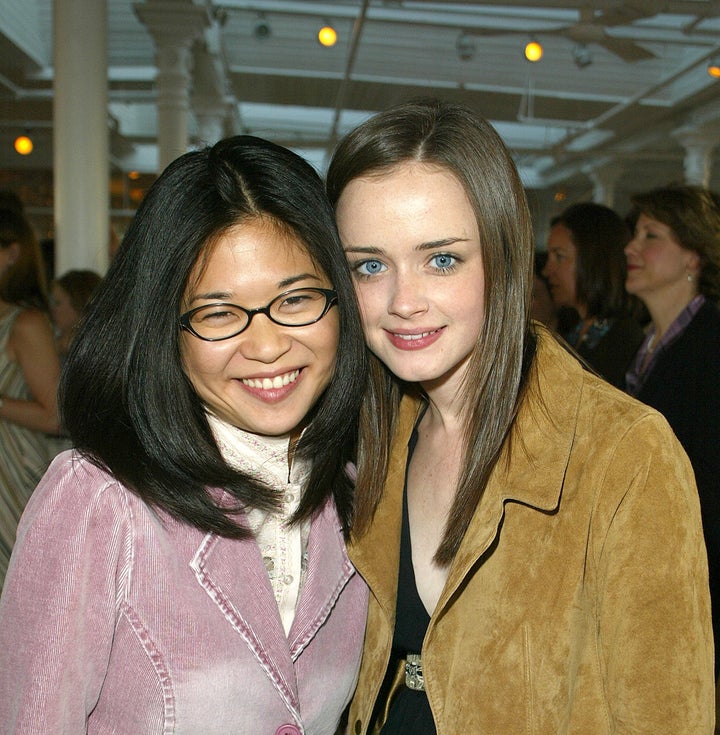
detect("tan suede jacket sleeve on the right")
[594,413,714,735]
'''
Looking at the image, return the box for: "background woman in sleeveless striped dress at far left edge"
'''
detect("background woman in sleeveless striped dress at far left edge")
[0,209,60,588]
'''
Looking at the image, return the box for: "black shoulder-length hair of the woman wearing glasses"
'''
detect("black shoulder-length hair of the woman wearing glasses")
[60,136,366,538]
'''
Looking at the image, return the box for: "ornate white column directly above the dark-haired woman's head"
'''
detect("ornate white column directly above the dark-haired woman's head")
[134,0,209,170]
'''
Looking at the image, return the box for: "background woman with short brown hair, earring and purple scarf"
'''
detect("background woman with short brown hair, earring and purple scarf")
[625,186,720,696]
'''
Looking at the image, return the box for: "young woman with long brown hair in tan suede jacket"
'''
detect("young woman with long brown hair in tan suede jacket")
[327,100,713,735]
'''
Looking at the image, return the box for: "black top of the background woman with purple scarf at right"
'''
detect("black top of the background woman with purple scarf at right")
[637,301,720,675]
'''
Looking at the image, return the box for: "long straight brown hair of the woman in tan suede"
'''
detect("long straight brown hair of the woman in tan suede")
[327,99,534,565]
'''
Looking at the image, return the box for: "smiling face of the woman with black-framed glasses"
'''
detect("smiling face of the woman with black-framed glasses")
[181,219,339,436]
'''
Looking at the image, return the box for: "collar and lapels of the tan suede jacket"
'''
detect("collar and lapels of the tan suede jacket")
[350,327,583,621]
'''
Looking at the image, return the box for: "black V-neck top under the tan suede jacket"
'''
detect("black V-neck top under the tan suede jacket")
[381,428,436,735]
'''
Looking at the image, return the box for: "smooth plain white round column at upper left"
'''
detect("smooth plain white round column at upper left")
[53,0,110,275]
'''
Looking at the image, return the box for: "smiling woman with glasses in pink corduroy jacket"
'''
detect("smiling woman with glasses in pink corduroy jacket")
[0,136,367,735]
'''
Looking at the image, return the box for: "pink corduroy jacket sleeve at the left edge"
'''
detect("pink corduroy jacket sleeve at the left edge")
[0,453,129,735]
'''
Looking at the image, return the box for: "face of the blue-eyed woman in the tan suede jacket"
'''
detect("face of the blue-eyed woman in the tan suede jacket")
[337,162,484,396]
